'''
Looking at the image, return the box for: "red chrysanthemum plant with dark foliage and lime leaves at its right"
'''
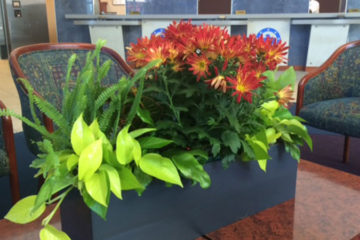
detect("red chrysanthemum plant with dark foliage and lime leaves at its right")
[128,21,311,170]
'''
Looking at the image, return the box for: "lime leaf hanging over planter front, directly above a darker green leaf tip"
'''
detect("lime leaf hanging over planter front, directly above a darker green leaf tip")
[85,172,110,207]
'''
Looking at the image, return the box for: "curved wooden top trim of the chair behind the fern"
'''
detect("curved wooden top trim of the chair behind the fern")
[9,43,134,132]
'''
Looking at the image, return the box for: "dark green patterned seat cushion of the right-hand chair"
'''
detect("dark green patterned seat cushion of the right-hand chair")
[299,97,360,137]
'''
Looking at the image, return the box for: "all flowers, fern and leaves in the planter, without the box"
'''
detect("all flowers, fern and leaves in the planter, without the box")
[0,22,312,239]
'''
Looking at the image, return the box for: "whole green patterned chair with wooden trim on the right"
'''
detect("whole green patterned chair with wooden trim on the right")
[296,41,360,162]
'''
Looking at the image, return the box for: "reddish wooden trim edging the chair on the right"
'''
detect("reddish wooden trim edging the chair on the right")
[296,41,360,115]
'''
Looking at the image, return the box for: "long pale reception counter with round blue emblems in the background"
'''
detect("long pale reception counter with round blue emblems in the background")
[65,13,360,68]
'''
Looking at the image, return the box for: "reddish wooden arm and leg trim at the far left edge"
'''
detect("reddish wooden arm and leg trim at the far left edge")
[0,101,20,204]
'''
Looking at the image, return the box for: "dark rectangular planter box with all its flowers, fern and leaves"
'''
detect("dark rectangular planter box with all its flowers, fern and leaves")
[0,22,311,239]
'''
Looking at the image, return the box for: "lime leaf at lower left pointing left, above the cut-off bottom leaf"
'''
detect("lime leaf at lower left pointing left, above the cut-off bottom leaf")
[4,195,45,224]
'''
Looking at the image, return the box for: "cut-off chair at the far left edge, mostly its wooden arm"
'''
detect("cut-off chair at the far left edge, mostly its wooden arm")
[0,101,20,204]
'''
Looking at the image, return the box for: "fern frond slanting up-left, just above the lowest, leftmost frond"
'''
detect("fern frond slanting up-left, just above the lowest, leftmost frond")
[34,96,70,134]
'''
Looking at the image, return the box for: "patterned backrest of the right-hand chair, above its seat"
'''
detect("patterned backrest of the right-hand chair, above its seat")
[304,41,360,105]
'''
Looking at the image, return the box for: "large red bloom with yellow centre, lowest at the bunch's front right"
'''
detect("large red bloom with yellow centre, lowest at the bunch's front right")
[227,66,262,103]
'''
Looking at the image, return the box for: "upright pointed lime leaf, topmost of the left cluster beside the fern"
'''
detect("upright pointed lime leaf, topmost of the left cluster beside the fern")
[71,114,95,155]
